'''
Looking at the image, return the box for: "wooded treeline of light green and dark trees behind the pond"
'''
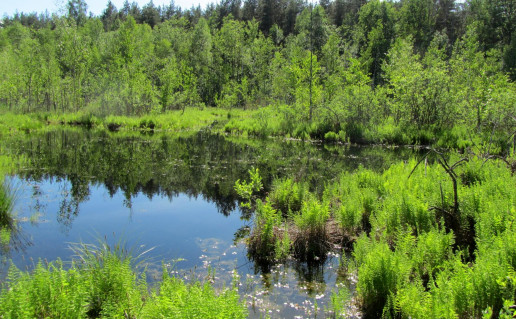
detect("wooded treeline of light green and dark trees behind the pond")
[0,0,516,142]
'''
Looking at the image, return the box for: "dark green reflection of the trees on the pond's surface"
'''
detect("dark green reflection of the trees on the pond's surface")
[4,130,420,224]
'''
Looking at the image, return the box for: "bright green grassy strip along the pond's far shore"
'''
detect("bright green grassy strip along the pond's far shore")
[0,105,514,154]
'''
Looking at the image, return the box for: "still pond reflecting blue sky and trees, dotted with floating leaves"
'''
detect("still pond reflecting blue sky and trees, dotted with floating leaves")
[2,130,416,317]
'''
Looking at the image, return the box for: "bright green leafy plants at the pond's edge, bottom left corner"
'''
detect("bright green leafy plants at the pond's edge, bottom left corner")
[0,242,247,318]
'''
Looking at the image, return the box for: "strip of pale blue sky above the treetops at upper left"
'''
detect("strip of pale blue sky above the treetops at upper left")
[0,0,212,16]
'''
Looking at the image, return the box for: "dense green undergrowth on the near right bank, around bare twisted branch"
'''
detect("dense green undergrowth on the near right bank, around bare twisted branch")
[239,156,516,318]
